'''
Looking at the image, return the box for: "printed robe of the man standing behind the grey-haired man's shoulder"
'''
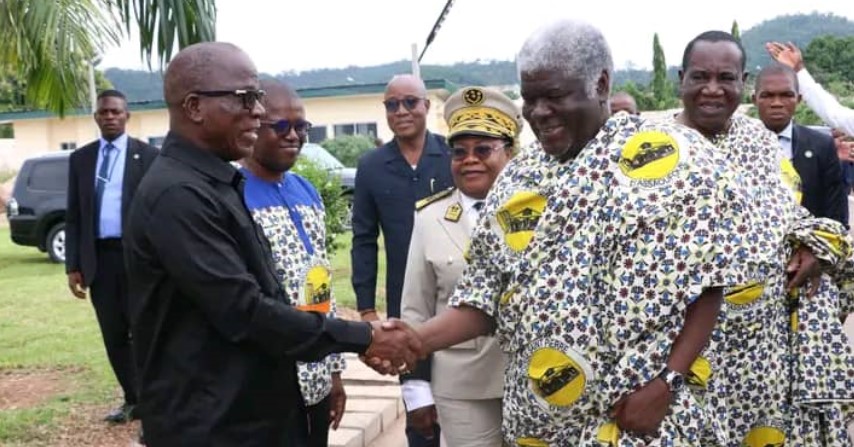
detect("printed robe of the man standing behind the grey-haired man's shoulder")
[688,115,854,446]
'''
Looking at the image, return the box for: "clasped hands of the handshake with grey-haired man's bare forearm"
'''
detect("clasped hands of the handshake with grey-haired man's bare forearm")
[362,306,494,375]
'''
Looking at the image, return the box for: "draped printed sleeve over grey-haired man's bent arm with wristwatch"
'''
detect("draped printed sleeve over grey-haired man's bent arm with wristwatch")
[603,160,750,402]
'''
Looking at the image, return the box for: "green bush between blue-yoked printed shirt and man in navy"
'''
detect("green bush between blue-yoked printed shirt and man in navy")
[293,157,349,255]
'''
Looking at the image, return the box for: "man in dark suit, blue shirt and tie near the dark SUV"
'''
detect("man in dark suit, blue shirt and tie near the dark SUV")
[65,90,157,423]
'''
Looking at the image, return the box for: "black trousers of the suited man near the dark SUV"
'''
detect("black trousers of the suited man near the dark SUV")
[90,239,137,405]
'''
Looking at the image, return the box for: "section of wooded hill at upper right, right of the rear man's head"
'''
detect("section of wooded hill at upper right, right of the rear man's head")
[741,13,854,72]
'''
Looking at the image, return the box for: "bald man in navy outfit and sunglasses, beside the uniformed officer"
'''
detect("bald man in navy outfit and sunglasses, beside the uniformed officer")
[351,75,453,447]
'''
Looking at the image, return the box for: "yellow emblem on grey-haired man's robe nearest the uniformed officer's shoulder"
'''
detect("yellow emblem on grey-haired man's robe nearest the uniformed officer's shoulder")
[496,191,546,252]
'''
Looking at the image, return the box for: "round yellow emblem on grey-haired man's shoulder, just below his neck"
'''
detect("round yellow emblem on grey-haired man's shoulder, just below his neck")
[620,130,679,180]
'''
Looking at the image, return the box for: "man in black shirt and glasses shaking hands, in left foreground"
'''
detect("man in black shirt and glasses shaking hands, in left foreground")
[126,43,420,446]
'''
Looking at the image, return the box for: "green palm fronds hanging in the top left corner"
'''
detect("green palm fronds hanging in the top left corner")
[0,0,216,115]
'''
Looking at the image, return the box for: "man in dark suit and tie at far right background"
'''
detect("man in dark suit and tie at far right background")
[753,64,848,226]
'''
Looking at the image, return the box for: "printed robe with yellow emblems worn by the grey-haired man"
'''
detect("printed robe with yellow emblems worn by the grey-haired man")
[451,114,750,446]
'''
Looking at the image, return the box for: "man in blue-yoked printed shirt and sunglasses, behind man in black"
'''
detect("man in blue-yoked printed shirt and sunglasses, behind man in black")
[241,80,347,447]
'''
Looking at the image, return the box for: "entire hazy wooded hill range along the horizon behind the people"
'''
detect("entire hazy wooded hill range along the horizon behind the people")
[104,13,854,101]
